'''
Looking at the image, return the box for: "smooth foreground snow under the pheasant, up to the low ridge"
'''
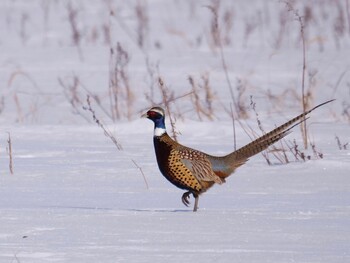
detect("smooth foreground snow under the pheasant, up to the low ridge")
[0,120,350,262]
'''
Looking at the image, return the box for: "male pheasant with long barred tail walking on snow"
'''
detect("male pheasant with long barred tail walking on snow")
[142,100,333,212]
